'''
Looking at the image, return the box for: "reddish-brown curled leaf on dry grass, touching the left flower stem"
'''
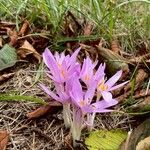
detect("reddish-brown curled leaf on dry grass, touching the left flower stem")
[26,102,62,119]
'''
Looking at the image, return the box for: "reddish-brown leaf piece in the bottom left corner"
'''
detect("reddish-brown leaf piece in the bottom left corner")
[0,131,9,150]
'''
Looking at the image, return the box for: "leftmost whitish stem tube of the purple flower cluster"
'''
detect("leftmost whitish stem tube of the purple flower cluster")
[63,103,71,128]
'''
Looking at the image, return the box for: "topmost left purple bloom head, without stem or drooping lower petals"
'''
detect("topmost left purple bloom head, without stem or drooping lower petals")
[43,48,80,83]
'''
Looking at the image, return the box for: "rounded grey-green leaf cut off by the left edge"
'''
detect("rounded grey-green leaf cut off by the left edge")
[0,44,17,71]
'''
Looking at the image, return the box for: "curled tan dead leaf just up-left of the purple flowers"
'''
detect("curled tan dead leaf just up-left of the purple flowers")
[17,40,41,63]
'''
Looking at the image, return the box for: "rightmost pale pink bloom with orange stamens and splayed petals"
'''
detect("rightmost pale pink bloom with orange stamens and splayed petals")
[97,70,129,103]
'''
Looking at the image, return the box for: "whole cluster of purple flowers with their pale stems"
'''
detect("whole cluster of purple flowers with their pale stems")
[40,48,127,145]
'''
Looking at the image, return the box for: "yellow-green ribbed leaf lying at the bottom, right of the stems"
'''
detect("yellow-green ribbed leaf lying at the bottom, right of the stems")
[85,130,127,150]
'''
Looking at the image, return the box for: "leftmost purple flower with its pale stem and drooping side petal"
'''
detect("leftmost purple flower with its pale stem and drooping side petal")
[40,48,80,127]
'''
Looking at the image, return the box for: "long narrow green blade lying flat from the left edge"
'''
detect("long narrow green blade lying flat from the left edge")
[0,94,47,105]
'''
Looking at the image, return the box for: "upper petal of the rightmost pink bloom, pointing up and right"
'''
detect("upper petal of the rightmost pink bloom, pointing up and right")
[105,70,122,88]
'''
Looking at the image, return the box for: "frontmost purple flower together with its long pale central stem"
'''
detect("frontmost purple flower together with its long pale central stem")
[70,79,117,145]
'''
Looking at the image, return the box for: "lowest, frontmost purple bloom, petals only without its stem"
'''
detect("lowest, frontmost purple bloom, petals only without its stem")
[70,79,117,113]
